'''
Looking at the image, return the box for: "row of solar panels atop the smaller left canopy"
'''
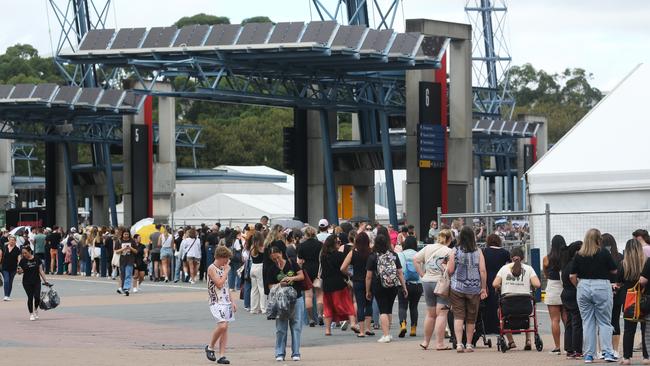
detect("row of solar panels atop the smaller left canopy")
[0,84,142,112]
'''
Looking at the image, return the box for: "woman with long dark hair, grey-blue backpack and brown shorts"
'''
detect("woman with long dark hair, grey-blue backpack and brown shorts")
[447,226,487,353]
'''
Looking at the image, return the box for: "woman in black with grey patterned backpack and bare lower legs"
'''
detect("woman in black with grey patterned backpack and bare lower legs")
[366,235,408,343]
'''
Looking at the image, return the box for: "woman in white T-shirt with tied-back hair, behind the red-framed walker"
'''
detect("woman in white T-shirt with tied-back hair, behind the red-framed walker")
[492,247,542,350]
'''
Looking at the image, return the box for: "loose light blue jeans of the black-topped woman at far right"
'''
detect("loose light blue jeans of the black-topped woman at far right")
[577,279,614,357]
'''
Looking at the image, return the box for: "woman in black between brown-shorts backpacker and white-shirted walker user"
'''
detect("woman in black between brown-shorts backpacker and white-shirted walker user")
[481,234,510,334]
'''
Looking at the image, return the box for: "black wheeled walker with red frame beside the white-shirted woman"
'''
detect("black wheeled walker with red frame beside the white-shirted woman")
[497,294,544,353]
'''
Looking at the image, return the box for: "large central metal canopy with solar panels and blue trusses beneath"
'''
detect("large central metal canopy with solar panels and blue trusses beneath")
[58,21,448,114]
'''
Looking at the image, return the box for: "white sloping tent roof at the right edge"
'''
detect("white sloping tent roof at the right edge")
[527,64,650,194]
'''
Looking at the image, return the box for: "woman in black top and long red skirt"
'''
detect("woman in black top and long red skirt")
[320,235,359,336]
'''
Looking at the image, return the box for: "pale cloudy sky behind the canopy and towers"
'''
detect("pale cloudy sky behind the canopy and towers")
[0,0,650,91]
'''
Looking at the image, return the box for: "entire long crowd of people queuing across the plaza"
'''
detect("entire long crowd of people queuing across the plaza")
[0,217,650,364]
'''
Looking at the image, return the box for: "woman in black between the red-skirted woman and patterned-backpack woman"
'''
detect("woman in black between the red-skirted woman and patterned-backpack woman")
[341,231,375,337]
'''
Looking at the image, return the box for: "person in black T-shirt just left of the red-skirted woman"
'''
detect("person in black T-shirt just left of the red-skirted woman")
[297,226,325,327]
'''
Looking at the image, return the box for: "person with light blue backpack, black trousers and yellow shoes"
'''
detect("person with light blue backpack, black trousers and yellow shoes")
[397,236,422,338]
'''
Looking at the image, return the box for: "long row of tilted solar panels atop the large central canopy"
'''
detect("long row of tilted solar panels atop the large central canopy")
[59,21,444,64]
